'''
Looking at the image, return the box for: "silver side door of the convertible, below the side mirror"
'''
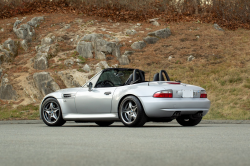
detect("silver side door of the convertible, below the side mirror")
[75,87,116,114]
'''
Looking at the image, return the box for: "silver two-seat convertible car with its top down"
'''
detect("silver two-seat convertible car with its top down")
[39,68,210,127]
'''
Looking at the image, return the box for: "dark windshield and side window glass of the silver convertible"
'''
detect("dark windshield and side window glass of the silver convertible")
[96,69,133,87]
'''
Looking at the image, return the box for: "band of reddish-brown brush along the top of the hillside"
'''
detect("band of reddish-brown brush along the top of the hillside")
[0,0,250,29]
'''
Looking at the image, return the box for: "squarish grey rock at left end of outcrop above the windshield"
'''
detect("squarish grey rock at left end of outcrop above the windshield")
[76,41,94,58]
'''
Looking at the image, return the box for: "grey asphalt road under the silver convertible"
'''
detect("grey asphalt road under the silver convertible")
[0,123,250,166]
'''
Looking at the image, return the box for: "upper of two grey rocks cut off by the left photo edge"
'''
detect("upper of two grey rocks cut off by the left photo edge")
[0,38,18,62]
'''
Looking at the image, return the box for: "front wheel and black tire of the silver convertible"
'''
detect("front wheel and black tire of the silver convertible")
[41,98,66,126]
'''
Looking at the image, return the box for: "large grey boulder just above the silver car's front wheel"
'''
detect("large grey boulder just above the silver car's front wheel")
[33,72,60,96]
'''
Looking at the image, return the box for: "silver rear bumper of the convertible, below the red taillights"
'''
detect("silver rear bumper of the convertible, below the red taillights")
[139,97,210,118]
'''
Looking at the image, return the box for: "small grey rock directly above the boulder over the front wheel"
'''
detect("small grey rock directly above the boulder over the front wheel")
[34,53,49,70]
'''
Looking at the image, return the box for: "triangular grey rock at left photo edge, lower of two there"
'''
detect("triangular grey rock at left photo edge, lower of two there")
[0,74,17,100]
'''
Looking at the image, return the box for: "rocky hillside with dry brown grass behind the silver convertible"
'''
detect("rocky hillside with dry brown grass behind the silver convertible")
[0,14,250,120]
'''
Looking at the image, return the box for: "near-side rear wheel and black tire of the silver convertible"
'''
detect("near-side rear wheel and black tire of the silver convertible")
[118,96,148,127]
